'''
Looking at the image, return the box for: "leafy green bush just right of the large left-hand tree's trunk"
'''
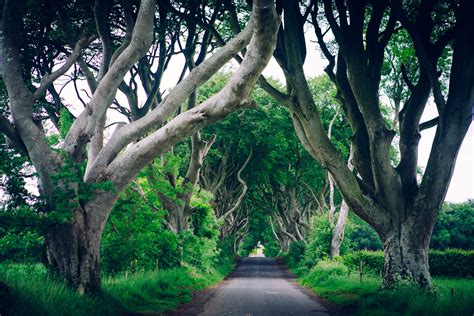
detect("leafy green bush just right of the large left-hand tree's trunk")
[100,189,180,274]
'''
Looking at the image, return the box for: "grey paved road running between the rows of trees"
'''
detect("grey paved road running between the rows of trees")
[199,257,329,316]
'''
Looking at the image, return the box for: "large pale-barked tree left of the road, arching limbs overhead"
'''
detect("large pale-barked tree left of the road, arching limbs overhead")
[0,0,278,293]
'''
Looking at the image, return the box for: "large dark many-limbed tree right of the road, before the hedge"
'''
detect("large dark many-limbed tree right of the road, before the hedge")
[264,0,474,288]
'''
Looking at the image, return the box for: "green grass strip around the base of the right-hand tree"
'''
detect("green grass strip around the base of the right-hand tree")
[300,273,474,316]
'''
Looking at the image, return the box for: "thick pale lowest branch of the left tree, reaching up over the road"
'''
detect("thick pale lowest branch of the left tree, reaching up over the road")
[105,0,279,193]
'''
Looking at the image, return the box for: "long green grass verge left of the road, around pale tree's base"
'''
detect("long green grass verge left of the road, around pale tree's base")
[0,262,233,316]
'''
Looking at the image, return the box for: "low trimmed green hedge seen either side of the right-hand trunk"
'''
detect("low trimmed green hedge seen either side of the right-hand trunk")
[343,249,474,277]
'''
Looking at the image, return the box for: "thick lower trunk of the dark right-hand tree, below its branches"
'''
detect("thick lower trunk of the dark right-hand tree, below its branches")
[381,219,432,289]
